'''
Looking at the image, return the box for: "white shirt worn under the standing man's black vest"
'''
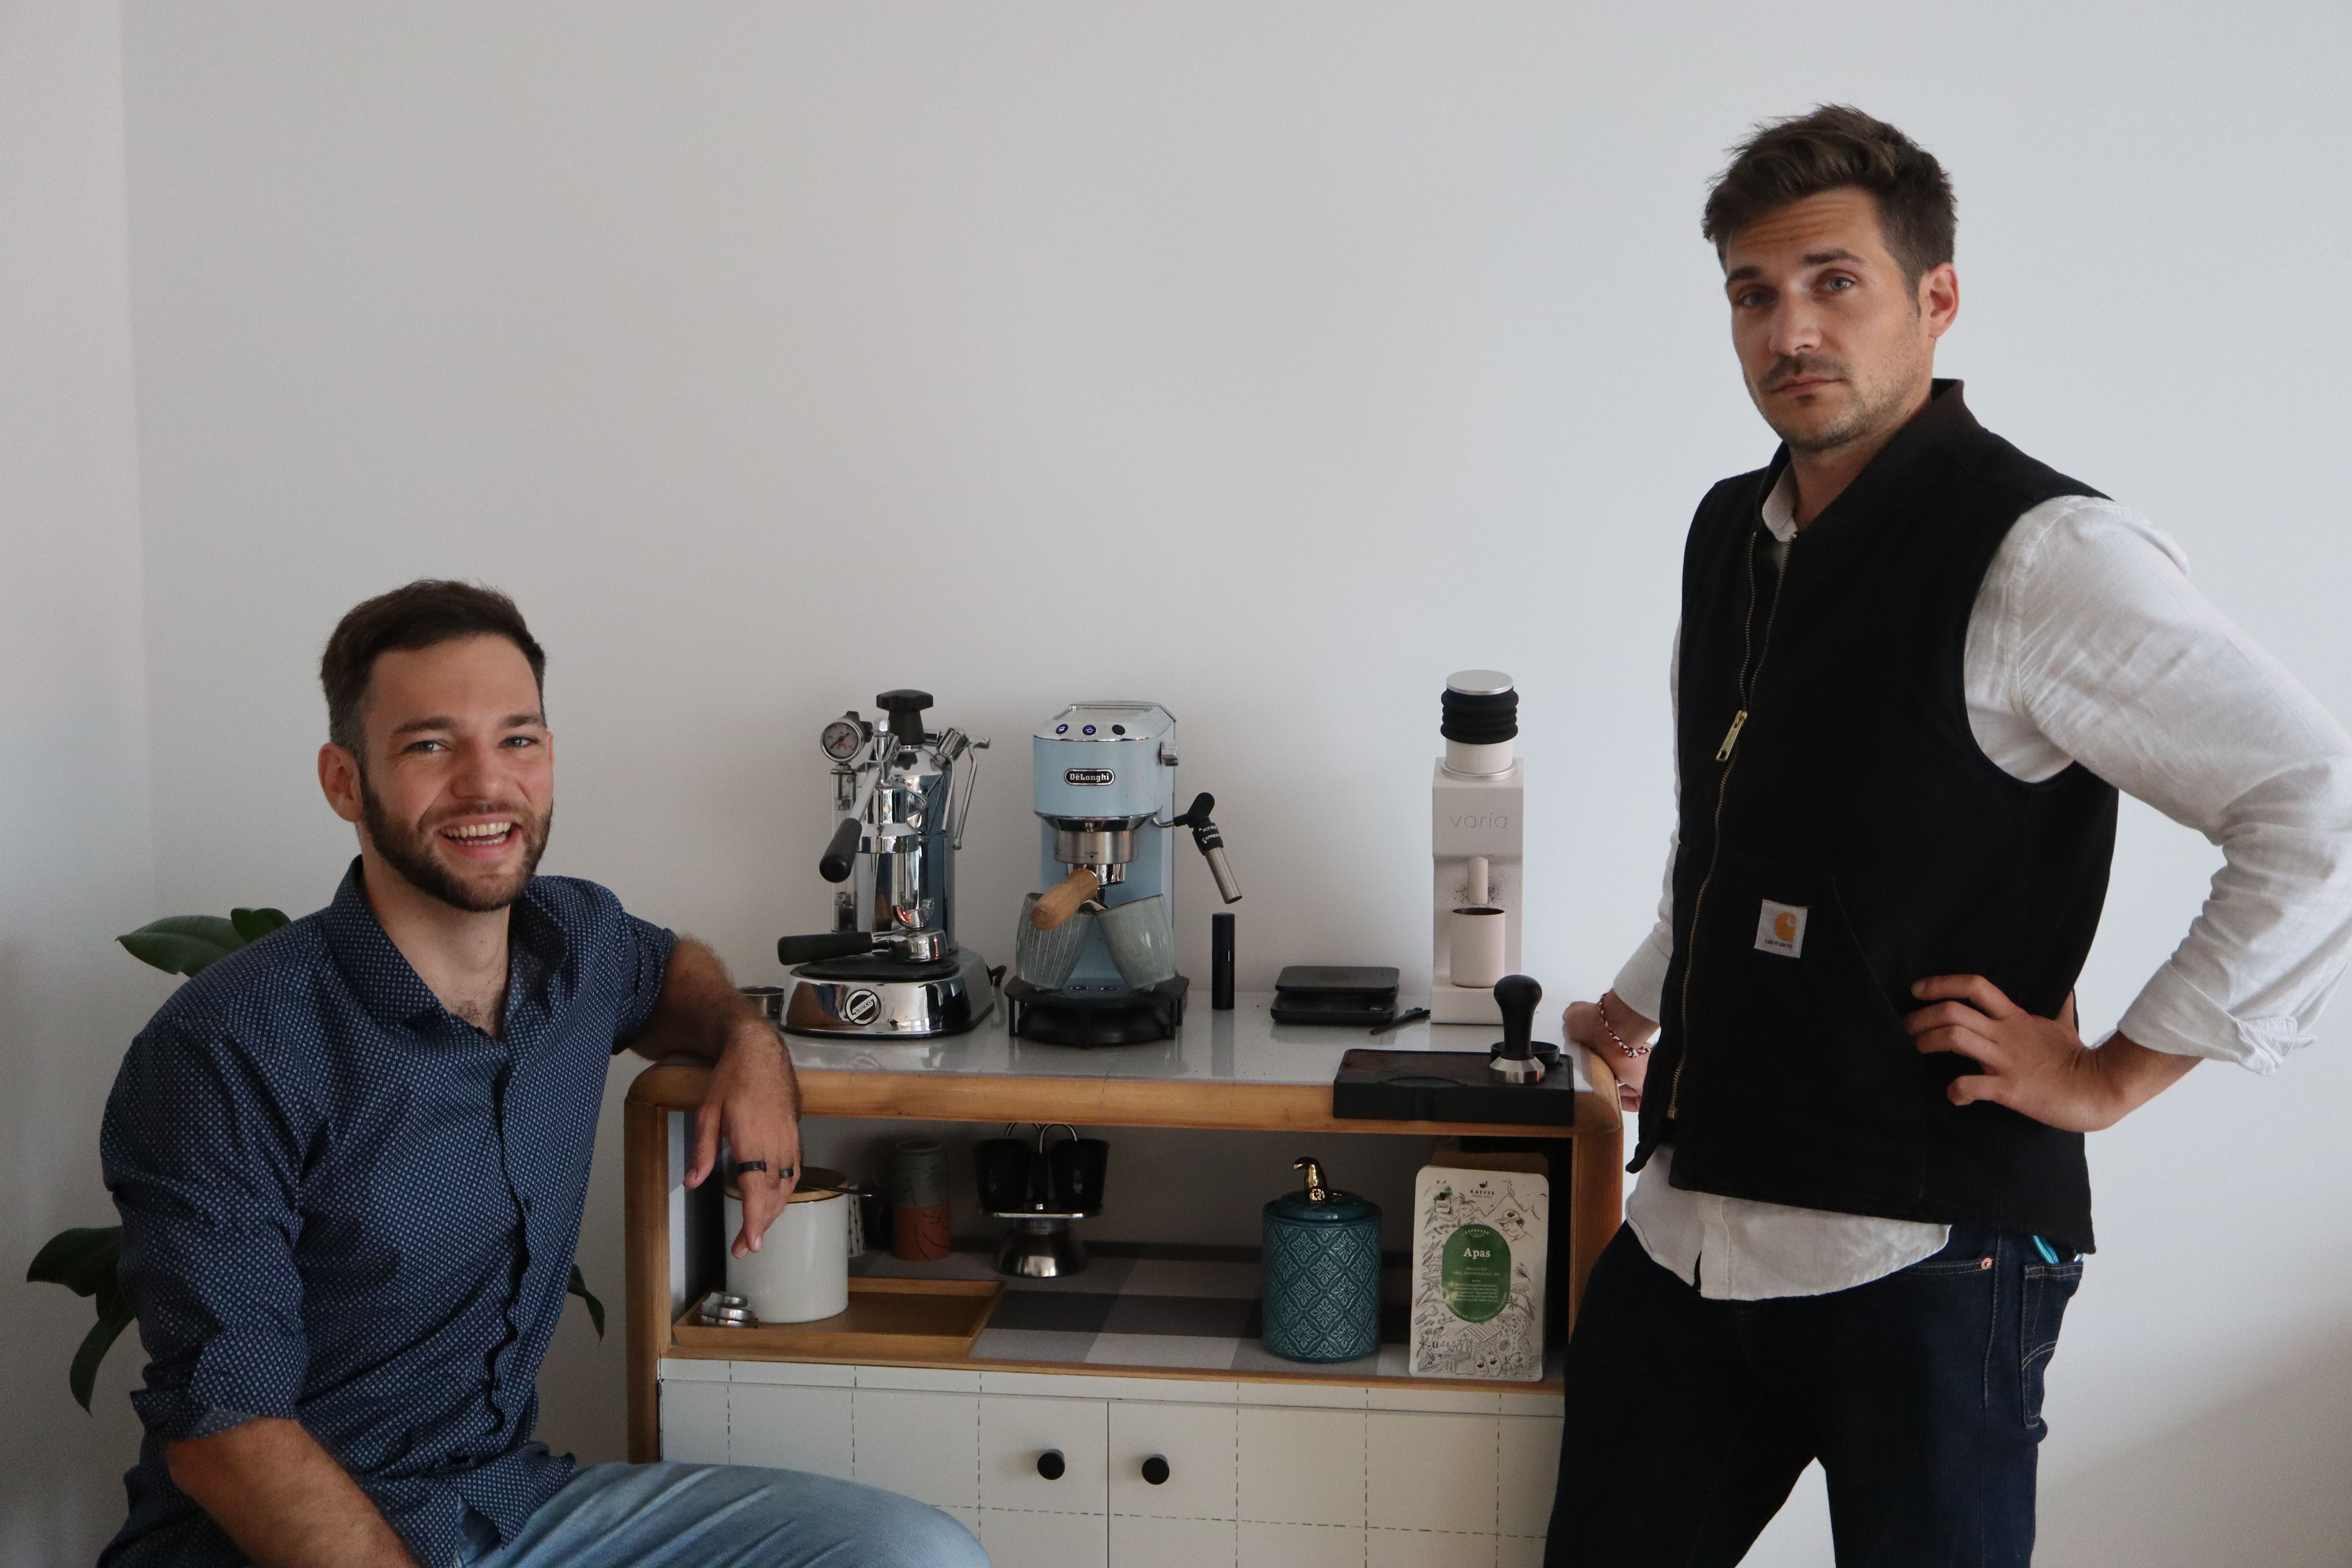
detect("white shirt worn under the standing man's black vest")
[1613,472,2352,1300]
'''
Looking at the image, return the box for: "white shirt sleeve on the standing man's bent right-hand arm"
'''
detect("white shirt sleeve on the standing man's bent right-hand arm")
[2006,501,2352,1072]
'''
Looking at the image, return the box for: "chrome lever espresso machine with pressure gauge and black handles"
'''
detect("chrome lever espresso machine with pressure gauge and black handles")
[776,689,995,1039]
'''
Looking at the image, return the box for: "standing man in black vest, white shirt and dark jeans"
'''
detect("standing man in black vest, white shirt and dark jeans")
[1545,108,2352,1568]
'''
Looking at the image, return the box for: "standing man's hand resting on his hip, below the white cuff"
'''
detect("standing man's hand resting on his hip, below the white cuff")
[1903,976,2197,1133]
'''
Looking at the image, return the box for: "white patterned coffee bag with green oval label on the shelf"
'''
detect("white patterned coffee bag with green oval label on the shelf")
[1409,1166,1552,1382]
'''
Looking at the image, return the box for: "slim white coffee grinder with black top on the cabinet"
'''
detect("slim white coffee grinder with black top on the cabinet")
[1430,670,1526,1023]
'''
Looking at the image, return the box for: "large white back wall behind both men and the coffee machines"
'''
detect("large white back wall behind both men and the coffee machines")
[12,0,2352,1566]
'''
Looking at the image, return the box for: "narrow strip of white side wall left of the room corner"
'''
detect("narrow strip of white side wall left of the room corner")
[0,0,169,1563]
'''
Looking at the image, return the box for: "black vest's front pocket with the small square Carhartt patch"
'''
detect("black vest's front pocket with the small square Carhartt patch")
[1677,849,1931,1199]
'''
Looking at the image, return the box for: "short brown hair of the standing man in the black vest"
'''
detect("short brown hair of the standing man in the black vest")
[1700,103,1959,287]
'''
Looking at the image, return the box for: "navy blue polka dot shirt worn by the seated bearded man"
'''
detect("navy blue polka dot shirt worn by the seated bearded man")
[99,860,675,1568]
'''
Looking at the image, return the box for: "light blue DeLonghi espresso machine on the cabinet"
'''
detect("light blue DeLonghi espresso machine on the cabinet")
[1004,703,1242,1046]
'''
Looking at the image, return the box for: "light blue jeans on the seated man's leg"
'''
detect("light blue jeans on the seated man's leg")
[463,1465,988,1568]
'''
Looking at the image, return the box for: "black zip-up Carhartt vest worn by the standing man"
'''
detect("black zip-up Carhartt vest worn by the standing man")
[1632,381,2114,1250]
